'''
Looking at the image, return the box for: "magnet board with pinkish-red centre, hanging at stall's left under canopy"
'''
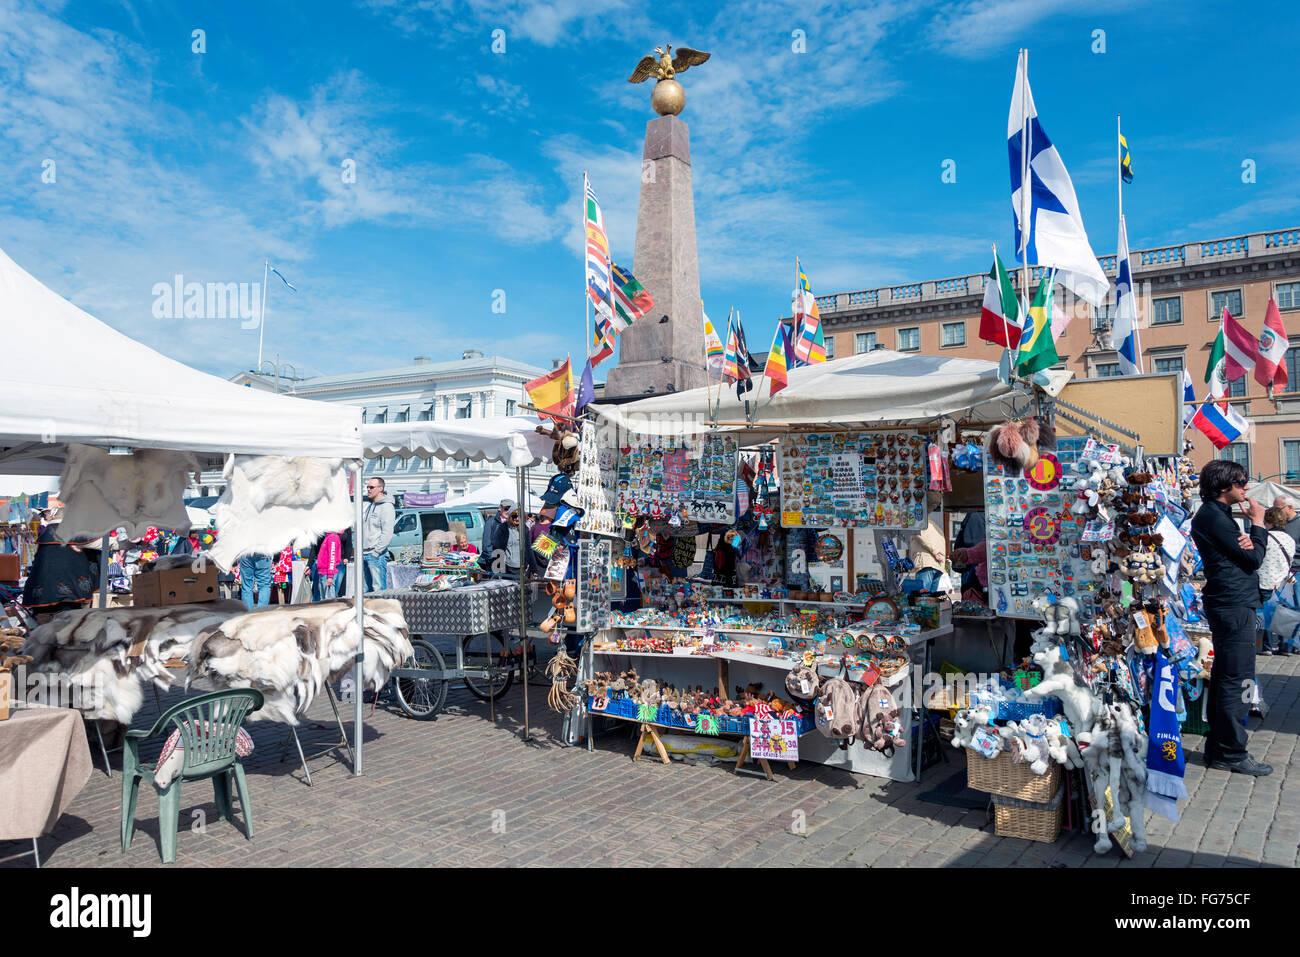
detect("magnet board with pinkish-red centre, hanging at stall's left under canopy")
[618,434,740,523]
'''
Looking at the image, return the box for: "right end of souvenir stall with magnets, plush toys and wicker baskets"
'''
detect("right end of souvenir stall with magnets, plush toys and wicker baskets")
[945,410,1213,856]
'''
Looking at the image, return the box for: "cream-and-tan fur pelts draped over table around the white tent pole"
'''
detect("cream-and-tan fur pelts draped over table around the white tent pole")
[190,598,412,724]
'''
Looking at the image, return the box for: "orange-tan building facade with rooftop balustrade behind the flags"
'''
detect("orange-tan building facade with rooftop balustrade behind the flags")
[816,229,1300,481]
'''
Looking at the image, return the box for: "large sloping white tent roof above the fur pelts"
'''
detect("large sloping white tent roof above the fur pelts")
[0,244,361,475]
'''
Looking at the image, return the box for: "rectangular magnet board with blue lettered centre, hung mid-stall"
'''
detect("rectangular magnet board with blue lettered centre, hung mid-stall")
[780,432,927,528]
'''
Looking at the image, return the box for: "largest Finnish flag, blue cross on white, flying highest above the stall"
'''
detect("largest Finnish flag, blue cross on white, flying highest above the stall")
[1006,49,1110,308]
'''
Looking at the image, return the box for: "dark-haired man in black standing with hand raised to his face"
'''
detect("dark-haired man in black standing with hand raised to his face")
[1192,459,1273,776]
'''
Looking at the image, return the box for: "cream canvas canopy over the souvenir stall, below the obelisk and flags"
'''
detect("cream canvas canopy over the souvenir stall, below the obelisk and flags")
[592,350,1071,434]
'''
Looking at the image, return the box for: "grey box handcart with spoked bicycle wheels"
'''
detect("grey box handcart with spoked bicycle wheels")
[374,580,528,720]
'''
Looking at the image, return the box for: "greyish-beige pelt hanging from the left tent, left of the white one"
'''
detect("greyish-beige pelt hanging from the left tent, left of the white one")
[59,445,197,547]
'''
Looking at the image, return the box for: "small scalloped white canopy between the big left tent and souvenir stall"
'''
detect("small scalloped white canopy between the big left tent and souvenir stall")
[364,415,555,468]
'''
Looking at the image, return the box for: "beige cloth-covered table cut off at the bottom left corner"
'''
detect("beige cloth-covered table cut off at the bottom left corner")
[0,707,90,840]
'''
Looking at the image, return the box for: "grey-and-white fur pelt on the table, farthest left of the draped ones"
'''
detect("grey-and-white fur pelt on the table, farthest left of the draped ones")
[22,601,244,724]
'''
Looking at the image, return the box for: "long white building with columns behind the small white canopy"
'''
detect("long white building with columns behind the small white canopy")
[214,350,551,497]
